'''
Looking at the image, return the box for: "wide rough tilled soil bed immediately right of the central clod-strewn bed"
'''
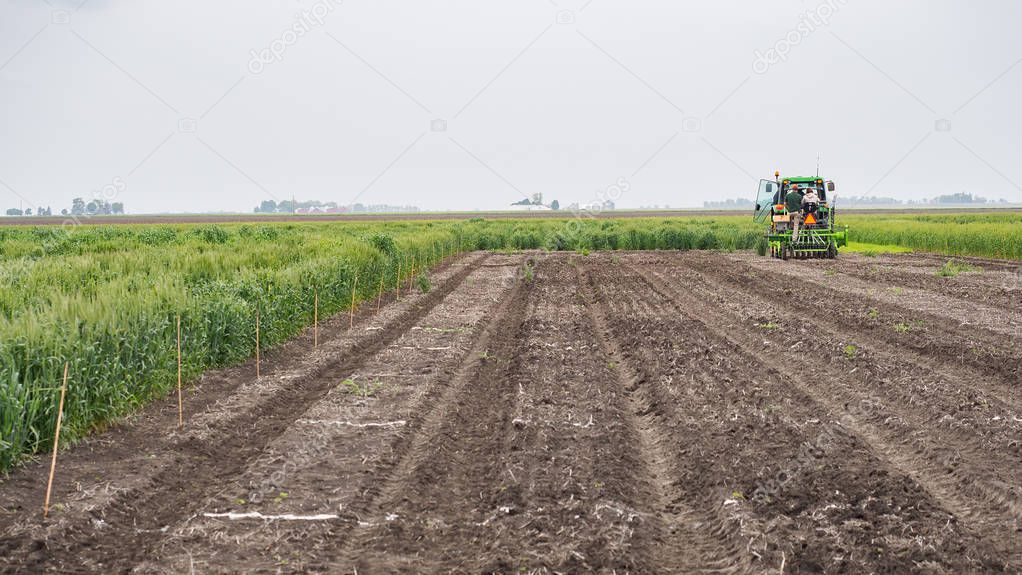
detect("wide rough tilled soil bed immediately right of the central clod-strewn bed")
[594,256,998,572]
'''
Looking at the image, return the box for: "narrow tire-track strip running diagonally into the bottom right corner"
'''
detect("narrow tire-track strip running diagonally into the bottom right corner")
[634,255,1022,570]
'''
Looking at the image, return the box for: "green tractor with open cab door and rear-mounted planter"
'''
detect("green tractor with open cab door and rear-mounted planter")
[754,173,848,259]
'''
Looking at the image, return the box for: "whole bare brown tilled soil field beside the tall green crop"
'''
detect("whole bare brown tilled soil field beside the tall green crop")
[0,251,1022,574]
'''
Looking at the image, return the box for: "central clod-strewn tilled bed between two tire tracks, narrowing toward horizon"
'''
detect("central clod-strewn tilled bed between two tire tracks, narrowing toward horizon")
[468,254,675,573]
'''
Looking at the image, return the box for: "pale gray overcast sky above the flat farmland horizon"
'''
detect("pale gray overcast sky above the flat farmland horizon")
[0,0,1022,212]
